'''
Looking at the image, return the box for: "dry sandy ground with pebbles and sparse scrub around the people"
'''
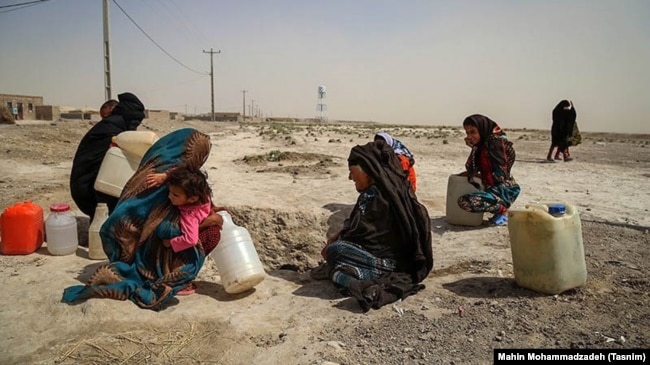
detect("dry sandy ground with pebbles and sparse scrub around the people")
[0,120,650,364]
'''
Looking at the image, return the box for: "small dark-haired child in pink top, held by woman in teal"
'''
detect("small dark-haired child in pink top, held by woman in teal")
[146,166,223,295]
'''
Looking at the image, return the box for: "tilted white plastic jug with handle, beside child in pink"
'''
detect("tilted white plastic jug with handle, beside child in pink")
[210,211,266,294]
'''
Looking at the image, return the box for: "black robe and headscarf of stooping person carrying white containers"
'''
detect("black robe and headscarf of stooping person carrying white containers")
[70,92,145,218]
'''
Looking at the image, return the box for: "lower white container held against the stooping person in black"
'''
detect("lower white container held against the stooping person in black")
[94,147,142,198]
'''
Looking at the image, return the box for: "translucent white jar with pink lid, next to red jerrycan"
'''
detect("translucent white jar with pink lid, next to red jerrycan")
[45,203,79,256]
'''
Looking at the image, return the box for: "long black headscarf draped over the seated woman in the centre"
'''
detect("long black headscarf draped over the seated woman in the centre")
[348,140,433,308]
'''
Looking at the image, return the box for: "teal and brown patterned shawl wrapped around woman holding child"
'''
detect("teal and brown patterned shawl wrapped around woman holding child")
[63,128,211,311]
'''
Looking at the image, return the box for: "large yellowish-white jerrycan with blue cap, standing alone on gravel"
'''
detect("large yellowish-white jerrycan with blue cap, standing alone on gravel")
[508,203,587,294]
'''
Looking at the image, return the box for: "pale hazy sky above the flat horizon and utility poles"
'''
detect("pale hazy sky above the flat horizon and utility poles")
[0,0,650,133]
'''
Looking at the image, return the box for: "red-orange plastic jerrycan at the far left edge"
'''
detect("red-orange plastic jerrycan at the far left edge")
[0,201,45,255]
